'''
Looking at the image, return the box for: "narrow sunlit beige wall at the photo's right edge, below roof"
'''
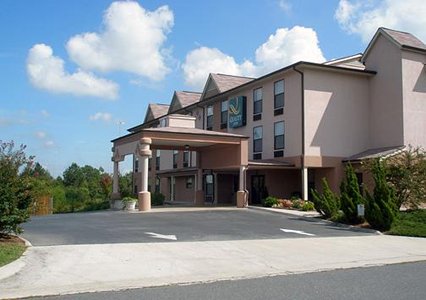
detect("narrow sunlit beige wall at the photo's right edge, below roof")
[402,51,426,147]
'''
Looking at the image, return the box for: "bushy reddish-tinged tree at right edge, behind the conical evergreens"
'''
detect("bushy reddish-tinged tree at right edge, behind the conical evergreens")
[385,147,426,209]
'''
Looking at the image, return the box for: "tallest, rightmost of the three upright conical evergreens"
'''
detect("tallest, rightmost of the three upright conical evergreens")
[365,160,397,231]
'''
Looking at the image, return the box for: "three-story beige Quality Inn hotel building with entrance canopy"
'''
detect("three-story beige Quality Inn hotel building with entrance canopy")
[112,28,426,209]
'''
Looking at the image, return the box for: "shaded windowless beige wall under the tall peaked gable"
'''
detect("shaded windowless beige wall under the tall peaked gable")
[365,36,404,148]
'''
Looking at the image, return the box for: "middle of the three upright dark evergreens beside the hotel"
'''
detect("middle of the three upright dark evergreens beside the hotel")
[340,164,365,224]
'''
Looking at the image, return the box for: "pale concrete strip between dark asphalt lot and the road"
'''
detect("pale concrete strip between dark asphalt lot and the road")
[0,235,426,299]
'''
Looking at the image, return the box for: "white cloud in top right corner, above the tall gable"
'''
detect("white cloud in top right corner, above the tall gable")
[334,0,426,43]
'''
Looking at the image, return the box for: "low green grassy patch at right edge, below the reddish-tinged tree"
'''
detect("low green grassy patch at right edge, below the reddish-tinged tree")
[387,209,426,237]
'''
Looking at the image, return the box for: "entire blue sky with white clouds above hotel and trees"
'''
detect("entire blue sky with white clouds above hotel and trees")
[0,0,426,176]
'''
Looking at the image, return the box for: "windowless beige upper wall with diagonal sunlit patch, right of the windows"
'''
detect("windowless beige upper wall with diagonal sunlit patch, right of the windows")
[304,69,369,157]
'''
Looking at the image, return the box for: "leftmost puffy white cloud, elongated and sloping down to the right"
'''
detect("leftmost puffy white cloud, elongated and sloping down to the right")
[27,44,118,99]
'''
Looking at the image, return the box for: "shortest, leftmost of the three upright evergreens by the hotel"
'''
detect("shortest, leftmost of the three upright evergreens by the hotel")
[311,178,340,218]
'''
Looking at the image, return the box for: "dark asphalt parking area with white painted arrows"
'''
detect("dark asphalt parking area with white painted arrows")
[23,208,376,246]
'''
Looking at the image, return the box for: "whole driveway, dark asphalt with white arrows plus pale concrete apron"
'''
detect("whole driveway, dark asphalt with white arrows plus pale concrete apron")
[0,209,426,299]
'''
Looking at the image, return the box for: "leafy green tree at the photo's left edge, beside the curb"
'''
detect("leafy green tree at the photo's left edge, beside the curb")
[0,141,33,234]
